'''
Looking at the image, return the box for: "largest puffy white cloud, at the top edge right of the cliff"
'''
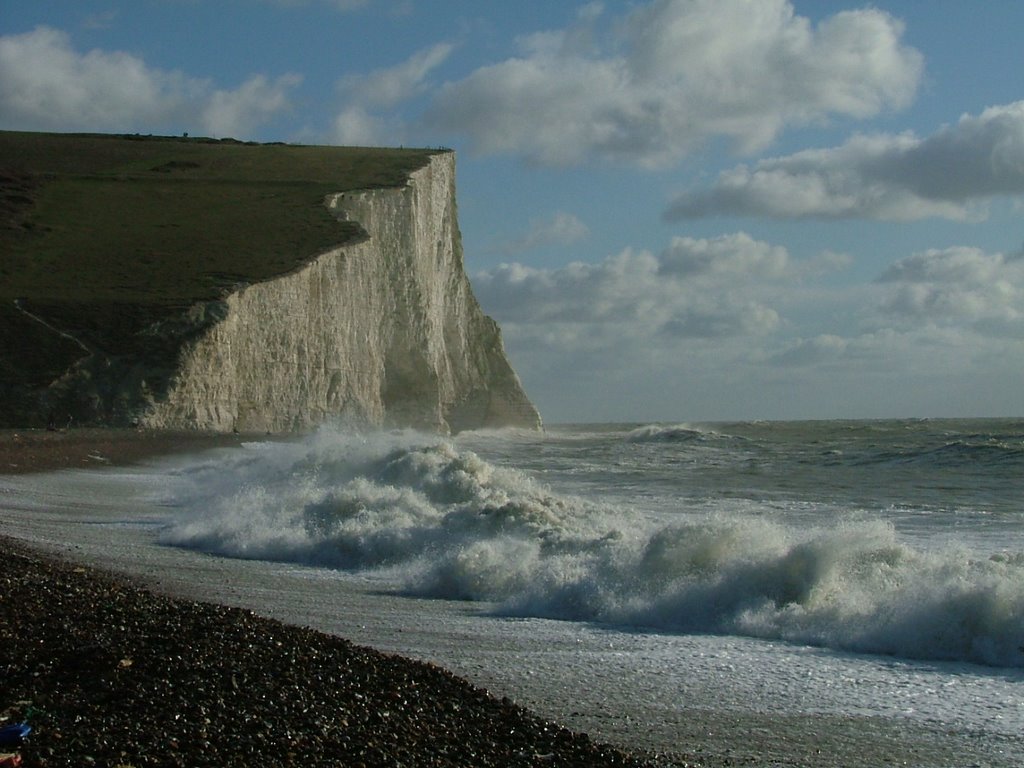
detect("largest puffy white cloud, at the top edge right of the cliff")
[429,0,922,167]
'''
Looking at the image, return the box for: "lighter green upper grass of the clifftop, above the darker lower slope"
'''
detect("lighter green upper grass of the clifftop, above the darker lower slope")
[0,131,436,307]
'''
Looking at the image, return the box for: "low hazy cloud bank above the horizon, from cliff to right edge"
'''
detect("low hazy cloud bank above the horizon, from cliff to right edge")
[474,232,1024,420]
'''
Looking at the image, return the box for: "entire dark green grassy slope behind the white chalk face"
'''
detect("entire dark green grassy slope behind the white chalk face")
[0,131,433,426]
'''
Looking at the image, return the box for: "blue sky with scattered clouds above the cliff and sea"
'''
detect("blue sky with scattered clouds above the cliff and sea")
[0,0,1024,423]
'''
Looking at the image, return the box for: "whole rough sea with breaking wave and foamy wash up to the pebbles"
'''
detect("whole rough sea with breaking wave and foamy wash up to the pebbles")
[0,419,1024,766]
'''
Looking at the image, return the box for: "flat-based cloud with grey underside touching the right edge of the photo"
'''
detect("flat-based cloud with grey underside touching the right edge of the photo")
[666,101,1024,220]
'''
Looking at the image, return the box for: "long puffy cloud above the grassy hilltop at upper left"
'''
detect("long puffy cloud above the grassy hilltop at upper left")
[0,27,300,136]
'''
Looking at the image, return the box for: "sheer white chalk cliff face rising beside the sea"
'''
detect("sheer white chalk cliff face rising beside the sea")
[138,153,541,432]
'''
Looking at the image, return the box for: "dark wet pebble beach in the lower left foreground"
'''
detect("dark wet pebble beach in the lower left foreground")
[0,539,659,768]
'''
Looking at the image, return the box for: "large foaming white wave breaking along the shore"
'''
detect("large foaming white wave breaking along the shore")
[157,428,1024,667]
